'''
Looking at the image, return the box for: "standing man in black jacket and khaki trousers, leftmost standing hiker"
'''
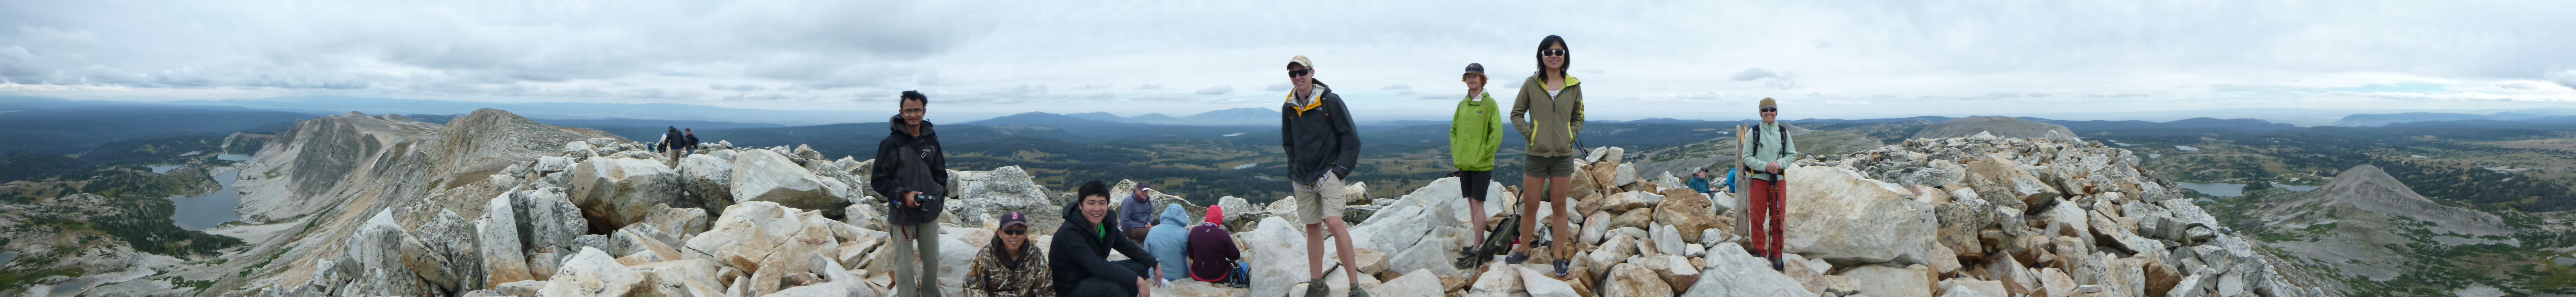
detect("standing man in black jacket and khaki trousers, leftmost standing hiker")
[868,90,948,297]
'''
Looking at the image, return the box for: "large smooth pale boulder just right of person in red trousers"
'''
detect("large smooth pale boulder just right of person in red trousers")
[1785,165,1937,263]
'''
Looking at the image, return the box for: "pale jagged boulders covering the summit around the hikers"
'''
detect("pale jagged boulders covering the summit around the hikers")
[20,109,2342,297]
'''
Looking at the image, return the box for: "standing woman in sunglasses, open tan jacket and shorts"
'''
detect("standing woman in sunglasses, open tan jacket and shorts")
[1504,36,1584,276]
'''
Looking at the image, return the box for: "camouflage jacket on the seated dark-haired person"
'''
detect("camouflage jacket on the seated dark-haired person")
[966,240,1056,297]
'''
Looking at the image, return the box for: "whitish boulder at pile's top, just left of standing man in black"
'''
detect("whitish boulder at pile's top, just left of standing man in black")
[732,150,855,209]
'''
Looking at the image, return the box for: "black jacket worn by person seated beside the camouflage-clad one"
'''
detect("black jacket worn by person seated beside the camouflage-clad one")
[1046,201,1157,294]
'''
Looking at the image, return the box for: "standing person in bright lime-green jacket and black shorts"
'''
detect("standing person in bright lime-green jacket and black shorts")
[1450,62,1502,243]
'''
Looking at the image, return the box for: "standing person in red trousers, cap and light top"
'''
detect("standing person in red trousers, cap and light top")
[1741,98,1798,271]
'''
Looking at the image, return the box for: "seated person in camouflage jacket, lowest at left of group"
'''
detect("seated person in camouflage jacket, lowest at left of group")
[966,212,1056,297]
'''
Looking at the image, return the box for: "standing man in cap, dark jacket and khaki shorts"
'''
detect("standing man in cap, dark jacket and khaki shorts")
[1280,57,1368,297]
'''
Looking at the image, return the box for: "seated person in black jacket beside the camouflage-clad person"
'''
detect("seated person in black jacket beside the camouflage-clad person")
[1046,181,1157,297]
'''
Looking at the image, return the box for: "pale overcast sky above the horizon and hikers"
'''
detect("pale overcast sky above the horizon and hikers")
[0,0,2576,119]
